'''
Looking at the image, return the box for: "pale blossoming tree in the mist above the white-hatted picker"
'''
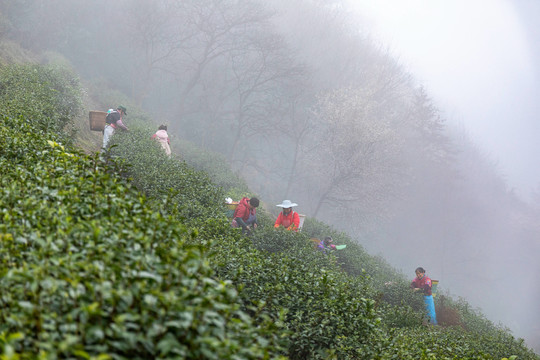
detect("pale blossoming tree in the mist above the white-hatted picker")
[304,88,400,216]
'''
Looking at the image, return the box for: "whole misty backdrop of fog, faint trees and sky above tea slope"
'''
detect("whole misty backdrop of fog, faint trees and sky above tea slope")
[0,0,540,352]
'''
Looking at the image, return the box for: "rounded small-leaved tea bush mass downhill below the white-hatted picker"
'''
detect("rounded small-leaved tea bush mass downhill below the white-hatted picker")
[209,233,380,359]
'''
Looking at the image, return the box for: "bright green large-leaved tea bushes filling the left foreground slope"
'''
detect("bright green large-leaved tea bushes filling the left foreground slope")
[0,114,279,359]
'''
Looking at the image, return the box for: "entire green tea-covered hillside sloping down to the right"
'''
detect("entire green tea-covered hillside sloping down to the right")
[0,65,539,359]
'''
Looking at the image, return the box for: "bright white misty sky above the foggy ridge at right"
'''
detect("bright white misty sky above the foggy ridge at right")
[350,0,540,198]
